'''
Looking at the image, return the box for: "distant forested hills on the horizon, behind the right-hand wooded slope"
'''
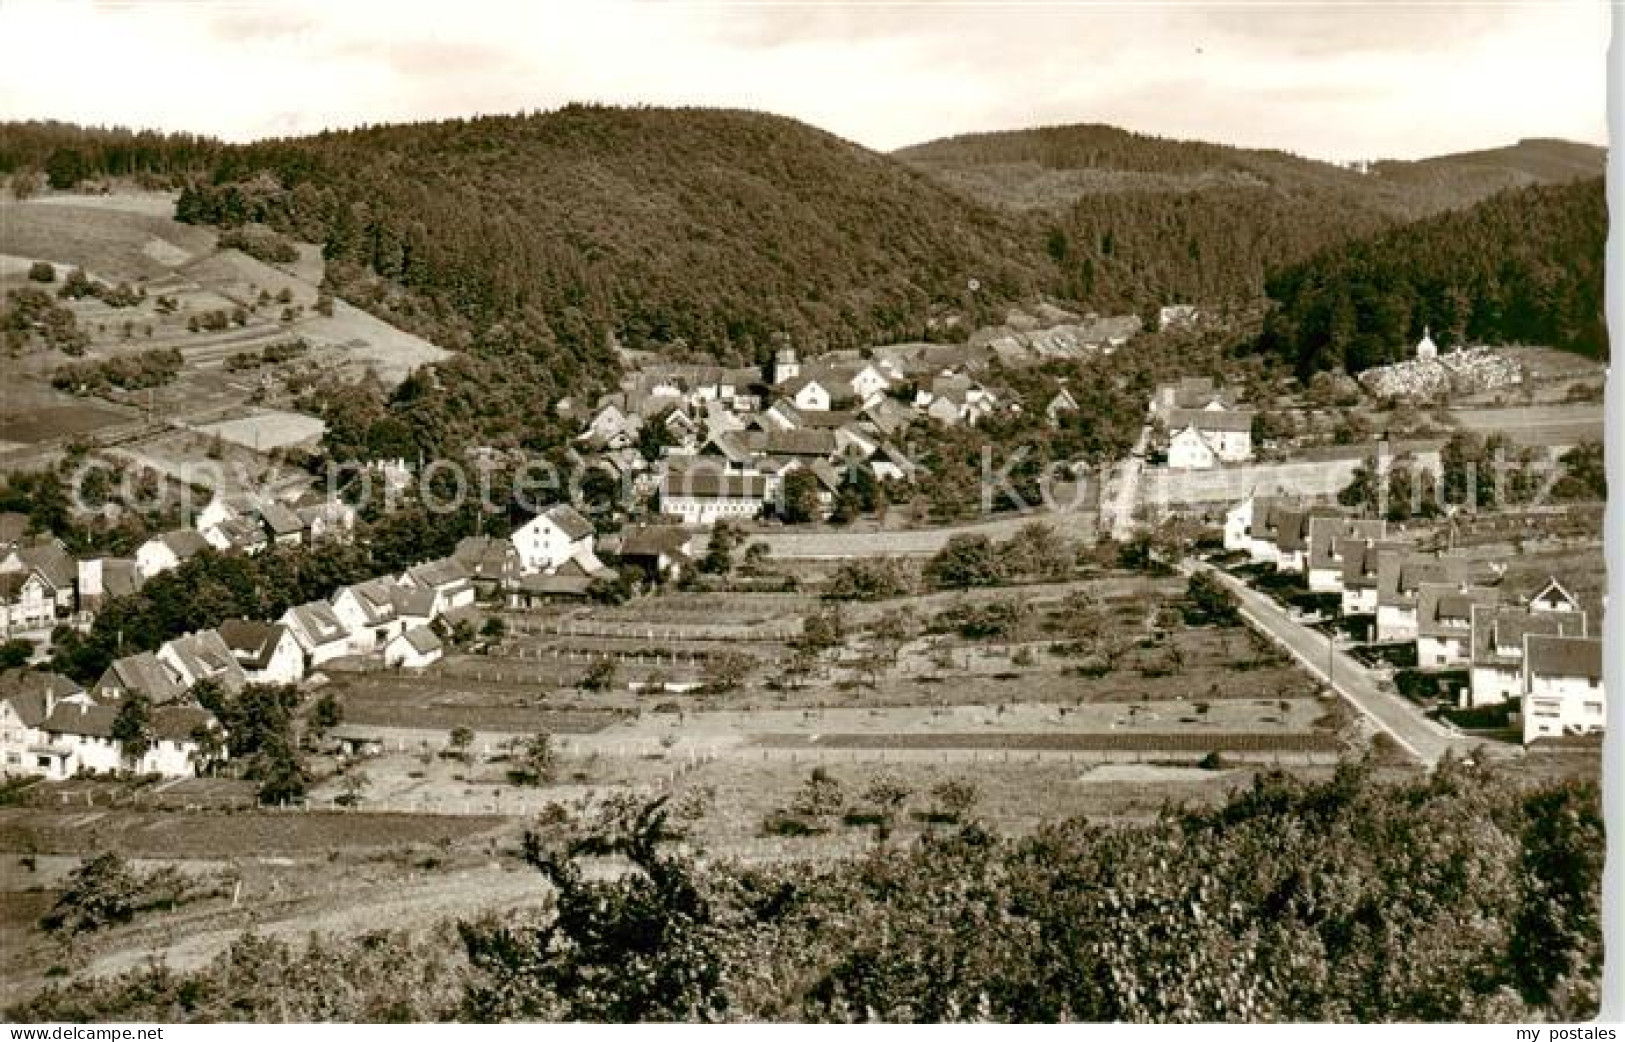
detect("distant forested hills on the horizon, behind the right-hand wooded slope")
[894,125,1606,307]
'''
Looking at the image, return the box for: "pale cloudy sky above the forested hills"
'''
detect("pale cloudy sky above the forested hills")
[0,0,1610,161]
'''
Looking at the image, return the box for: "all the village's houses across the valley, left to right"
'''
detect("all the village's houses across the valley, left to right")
[0,318,1606,780]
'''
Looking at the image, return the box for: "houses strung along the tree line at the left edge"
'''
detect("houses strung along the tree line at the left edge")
[0,504,633,779]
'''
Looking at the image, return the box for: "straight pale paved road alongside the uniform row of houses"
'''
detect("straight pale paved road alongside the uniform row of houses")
[1196,564,1474,767]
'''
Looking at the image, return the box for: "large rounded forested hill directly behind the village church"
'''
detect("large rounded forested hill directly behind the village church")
[179,106,1051,361]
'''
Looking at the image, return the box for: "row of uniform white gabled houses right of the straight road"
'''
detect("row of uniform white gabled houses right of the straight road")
[1224,496,1606,743]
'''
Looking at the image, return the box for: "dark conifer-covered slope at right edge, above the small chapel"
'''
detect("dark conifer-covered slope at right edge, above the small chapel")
[1261,177,1609,374]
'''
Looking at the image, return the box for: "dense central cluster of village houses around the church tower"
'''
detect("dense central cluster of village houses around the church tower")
[577,345,1077,525]
